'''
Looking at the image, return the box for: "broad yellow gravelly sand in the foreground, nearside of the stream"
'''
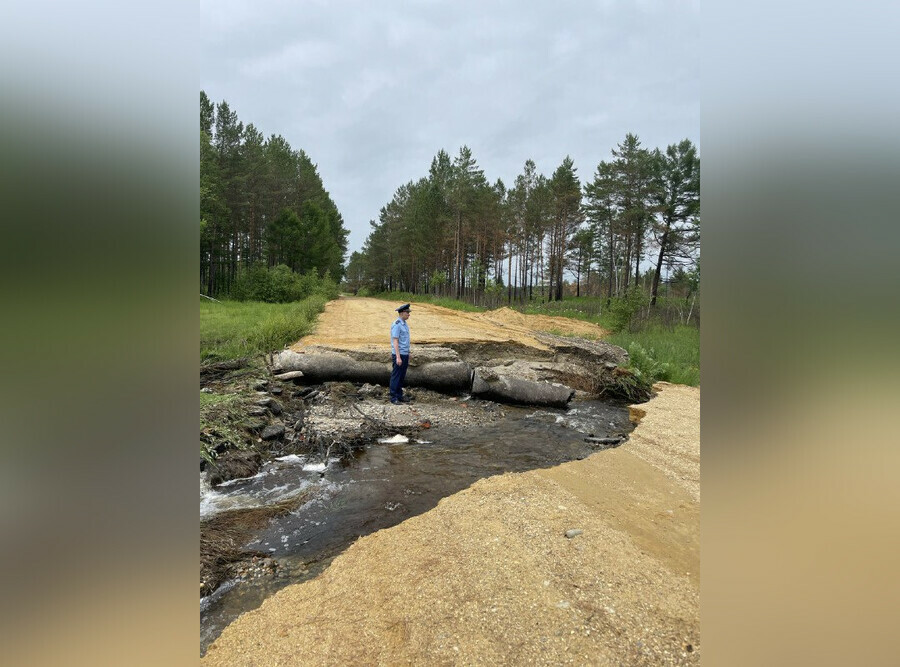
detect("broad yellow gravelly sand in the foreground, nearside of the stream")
[202,376,700,665]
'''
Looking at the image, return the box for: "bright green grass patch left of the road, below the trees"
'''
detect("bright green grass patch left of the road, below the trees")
[200,296,327,361]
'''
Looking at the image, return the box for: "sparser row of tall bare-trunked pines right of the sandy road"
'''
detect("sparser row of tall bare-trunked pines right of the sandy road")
[347,133,700,304]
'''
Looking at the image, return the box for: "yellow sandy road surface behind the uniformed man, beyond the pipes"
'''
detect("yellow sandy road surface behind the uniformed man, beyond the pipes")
[292,297,607,351]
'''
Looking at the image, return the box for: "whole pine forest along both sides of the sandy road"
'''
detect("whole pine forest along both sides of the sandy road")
[200,91,700,306]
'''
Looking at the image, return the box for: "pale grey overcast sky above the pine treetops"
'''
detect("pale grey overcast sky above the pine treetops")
[200,0,700,252]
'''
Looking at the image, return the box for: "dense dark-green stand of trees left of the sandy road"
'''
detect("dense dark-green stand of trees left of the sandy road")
[200,91,347,296]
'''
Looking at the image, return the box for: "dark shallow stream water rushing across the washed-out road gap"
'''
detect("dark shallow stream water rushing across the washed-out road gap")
[201,401,632,652]
